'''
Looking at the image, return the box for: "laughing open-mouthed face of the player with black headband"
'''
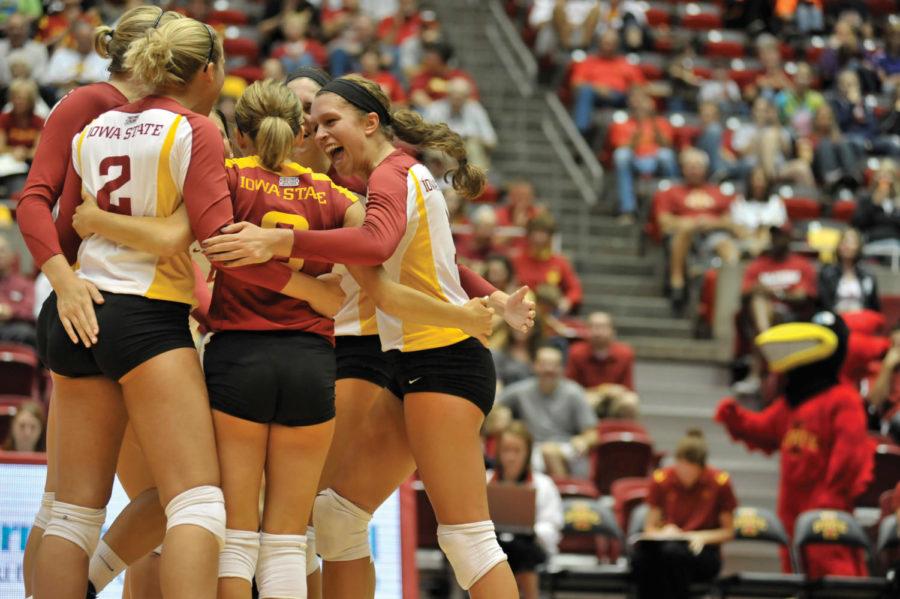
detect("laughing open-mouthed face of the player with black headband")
[311,93,377,178]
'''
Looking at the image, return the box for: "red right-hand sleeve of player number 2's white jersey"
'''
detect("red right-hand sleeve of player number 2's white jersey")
[178,116,291,291]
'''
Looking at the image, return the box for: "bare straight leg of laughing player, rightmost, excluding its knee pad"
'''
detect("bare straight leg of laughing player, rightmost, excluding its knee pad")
[404,393,519,599]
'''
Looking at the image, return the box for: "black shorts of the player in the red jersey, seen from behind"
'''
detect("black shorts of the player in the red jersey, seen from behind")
[203,331,335,426]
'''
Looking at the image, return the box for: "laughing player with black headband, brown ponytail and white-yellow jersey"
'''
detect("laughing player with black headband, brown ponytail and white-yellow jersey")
[206,76,517,598]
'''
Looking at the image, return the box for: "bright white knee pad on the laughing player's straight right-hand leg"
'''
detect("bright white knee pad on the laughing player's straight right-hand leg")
[438,520,506,591]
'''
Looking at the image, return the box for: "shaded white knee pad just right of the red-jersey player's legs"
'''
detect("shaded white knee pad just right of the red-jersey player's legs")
[313,489,372,562]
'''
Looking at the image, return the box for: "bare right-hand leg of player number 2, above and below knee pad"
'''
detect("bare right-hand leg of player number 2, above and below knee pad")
[120,348,219,599]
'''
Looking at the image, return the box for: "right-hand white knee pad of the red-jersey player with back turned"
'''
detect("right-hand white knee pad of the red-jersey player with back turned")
[256,532,306,599]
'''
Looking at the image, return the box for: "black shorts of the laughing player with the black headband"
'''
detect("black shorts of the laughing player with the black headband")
[394,337,497,415]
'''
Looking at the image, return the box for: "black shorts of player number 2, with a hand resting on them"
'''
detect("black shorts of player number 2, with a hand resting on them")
[37,291,194,381]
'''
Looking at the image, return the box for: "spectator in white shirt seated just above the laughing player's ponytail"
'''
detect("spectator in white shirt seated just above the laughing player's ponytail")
[424,77,497,169]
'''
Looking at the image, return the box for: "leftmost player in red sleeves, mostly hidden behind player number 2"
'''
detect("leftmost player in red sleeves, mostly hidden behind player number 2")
[17,6,190,594]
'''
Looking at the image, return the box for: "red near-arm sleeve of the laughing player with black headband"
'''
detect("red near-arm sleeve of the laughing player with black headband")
[291,166,407,266]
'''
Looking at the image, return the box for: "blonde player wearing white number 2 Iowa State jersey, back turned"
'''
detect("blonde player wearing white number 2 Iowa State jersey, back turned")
[35,19,360,599]
